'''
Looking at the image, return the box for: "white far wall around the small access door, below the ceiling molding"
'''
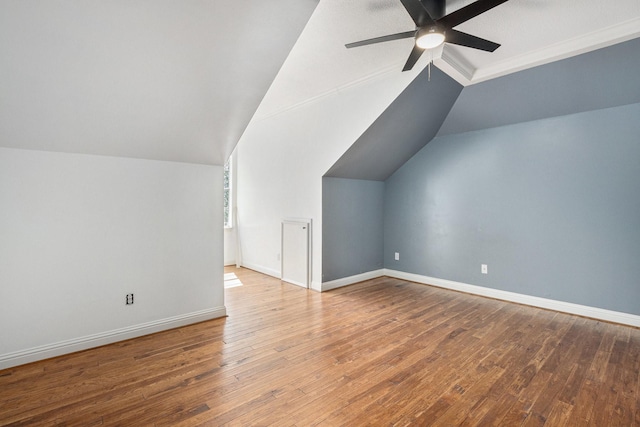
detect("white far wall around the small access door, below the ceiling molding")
[236,72,415,289]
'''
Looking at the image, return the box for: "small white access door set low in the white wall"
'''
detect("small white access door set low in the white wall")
[281,220,311,288]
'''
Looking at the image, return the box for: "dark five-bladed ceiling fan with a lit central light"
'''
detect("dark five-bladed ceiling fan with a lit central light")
[345,0,508,71]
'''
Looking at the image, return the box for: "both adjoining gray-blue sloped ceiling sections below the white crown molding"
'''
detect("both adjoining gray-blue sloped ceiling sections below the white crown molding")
[325,38,640,181]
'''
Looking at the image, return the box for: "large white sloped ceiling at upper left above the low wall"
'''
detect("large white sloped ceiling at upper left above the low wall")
[0,0,318,164]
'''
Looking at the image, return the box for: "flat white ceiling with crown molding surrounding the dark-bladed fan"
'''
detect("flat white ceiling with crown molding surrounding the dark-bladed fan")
[256,0,640,125]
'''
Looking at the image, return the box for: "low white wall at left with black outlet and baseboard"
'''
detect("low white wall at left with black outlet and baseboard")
[0,148,225,369]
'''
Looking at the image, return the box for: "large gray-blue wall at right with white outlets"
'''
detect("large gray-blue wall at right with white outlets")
[382,104,640,315]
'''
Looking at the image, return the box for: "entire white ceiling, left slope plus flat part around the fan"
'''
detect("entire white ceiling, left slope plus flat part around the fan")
[0,0,640,164]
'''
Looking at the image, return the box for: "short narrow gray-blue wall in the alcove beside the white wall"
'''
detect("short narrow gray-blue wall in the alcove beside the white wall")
[322,177,384,282]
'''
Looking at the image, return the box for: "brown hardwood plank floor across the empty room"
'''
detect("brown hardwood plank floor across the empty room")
[0,269,640,426]
